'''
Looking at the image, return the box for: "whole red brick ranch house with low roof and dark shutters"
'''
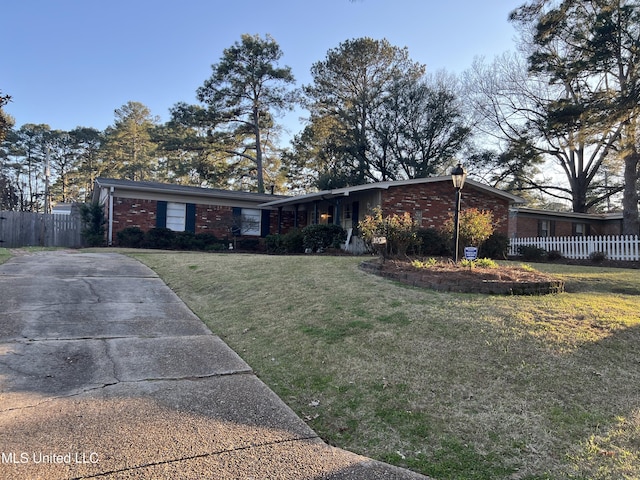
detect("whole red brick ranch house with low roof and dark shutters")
[93,176,523,245]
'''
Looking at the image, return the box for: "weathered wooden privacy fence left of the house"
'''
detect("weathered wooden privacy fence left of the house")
[0,211,82,248]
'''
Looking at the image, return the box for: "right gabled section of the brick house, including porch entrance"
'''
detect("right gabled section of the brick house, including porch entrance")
[262,176,524,246]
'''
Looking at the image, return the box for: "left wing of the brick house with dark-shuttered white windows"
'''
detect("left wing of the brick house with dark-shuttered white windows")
[93,178,294,245]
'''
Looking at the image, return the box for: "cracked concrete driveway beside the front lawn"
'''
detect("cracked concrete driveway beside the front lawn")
[0,251,425,480]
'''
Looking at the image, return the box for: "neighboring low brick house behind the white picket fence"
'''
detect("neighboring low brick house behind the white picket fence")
[509,207,622,238]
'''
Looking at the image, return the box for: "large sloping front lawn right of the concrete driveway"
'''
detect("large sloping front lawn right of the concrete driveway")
[134,252,640,480]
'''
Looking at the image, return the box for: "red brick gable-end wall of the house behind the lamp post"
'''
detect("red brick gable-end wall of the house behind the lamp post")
[381,182,509,235]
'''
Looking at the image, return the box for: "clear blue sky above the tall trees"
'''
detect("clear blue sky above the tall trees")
[0,0,523,134]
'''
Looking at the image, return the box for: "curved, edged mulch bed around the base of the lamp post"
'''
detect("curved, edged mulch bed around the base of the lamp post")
[360,259,564,295]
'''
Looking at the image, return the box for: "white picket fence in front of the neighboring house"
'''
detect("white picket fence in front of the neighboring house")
[509,235,640,261]
